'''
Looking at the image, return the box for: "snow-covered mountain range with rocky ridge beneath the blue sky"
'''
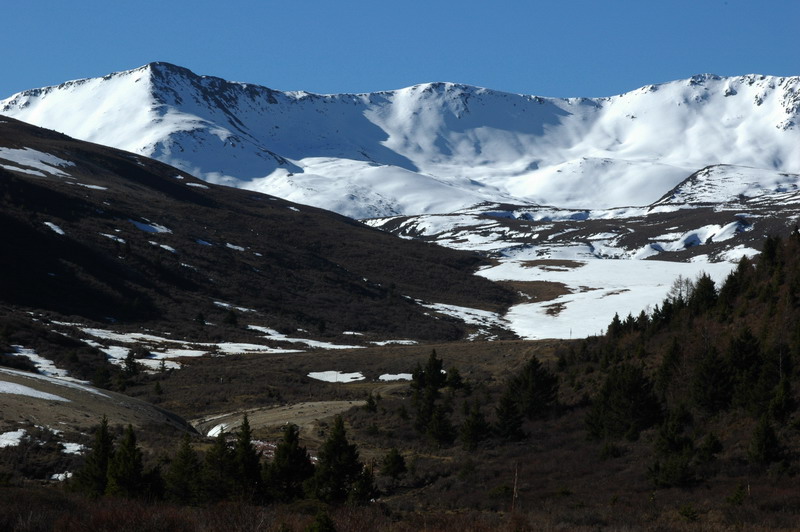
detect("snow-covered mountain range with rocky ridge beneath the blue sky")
[0,63,800,218]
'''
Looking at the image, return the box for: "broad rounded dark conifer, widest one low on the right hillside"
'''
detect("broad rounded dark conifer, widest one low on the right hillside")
[586,364,662,440]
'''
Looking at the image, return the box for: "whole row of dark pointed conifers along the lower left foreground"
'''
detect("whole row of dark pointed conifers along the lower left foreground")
[70,414,376,505]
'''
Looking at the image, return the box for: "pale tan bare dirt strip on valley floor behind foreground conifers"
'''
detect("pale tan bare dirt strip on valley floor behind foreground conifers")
[191,401,366,434]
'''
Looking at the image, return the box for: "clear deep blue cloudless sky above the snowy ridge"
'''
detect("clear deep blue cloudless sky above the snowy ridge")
[0,0,800,98]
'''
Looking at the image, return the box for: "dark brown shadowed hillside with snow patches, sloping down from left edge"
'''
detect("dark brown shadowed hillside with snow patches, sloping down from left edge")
[0,119,513,339]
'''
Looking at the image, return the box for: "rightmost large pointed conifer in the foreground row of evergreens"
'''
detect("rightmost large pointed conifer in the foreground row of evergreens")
[308,416,364,504]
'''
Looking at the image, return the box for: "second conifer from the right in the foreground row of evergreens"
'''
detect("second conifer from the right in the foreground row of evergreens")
[264,424,314,502]
